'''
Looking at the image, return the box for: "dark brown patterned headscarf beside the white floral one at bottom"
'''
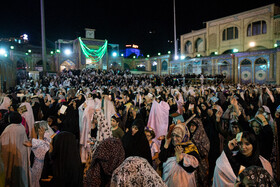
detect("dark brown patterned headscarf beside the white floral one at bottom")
[84,138,125,186]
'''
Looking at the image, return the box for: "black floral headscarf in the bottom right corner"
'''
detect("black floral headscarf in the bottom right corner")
[238,166,277,187]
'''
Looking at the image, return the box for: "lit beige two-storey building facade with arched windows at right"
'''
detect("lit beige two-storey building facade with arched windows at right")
[175,4,280,84]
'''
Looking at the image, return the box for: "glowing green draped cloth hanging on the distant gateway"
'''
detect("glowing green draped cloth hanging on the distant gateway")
[79,37,108,63]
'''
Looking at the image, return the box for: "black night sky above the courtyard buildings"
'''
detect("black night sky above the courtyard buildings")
[0,0,279,54]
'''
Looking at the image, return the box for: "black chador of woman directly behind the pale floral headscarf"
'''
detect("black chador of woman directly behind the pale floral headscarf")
[122,119,152,165]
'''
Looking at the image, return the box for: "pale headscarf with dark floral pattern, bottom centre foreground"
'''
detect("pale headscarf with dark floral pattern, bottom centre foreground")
[111,156,166,187]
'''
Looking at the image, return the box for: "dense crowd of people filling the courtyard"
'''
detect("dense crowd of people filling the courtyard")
[0,69,280,187]
